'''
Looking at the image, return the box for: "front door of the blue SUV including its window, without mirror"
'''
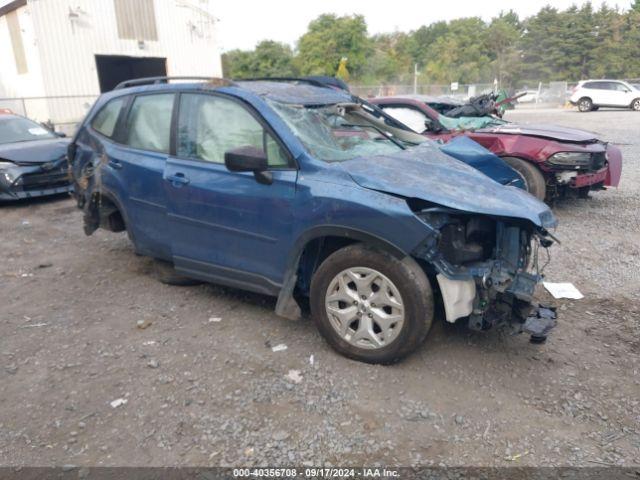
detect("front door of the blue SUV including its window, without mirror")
[164,93,297,294]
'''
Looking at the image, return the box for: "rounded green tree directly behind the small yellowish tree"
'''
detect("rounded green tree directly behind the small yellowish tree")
[295,14,371,76]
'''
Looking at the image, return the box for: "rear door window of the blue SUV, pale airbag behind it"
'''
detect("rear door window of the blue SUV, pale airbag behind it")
[125,93,175,153]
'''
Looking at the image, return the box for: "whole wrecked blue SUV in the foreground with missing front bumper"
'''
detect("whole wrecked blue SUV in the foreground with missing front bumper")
[68,78,556,363]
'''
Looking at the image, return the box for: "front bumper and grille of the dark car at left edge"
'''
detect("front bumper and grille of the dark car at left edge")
[0,158,73,201]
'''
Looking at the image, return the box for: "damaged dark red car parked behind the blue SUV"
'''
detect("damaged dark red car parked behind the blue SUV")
[368,95,622,200]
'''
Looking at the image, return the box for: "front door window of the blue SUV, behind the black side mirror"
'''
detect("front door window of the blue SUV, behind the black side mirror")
[176,93,289,168]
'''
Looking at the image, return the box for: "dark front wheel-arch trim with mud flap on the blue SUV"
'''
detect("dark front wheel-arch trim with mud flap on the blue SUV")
[275,225,408,320]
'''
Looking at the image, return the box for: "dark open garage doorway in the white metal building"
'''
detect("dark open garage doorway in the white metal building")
[96,55,167,93]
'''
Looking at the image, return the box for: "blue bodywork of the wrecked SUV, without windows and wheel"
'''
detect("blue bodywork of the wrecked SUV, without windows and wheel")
[69,82,557,338]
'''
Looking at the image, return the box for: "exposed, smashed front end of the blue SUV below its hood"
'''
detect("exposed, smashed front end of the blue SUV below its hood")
[413,209,556,342]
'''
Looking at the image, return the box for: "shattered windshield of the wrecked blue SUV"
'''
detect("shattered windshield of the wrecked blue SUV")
[269,101,404,162]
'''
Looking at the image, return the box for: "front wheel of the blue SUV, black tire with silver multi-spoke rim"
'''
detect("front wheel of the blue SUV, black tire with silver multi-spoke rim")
[310,244,434,364]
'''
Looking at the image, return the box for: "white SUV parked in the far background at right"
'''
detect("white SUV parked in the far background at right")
[569,80,640,112]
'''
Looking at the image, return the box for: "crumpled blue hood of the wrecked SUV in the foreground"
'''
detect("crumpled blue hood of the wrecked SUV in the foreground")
[340,143,557,228]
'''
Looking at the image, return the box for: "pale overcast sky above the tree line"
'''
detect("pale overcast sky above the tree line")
[210,0,631,51]
